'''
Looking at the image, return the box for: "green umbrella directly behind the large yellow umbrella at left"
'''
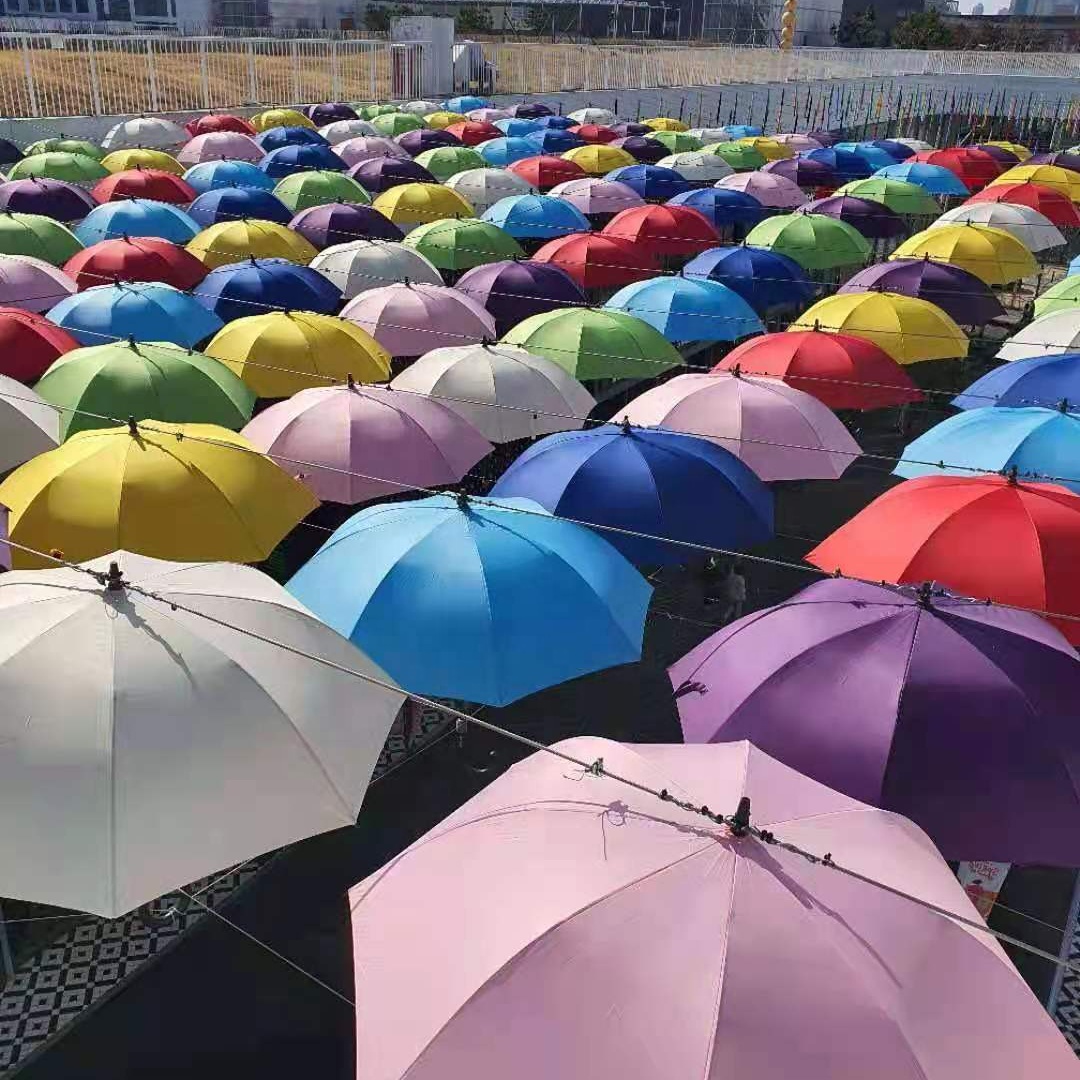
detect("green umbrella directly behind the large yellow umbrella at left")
[36,341,255,440]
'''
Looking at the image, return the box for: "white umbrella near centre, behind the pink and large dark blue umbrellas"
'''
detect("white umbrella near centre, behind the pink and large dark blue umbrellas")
[390,345,596,443]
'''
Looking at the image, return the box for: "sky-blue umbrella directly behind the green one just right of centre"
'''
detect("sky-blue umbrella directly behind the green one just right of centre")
[604,276,765,341]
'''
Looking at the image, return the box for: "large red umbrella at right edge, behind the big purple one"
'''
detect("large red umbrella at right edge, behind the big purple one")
[807,475,1080,645]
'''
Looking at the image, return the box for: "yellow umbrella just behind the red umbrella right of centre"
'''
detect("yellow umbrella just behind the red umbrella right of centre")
[786,293,968,367]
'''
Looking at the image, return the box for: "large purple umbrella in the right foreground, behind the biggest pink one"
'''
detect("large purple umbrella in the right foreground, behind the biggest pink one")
[669,579,1080,866]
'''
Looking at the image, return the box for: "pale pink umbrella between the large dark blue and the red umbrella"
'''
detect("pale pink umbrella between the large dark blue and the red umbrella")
[620,370,862,481]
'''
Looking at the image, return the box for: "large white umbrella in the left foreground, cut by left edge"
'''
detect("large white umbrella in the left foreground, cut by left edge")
[0,552,403,918]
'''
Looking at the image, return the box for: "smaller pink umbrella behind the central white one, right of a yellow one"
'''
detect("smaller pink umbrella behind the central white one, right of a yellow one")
[341,282,496,356]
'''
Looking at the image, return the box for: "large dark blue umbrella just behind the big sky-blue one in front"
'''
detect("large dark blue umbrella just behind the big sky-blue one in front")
[490,423,772,570]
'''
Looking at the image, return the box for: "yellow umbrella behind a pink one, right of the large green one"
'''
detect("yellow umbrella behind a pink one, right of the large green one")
[204,311,390,397]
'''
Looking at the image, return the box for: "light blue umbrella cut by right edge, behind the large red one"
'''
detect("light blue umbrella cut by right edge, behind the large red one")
[893,407,1080,494]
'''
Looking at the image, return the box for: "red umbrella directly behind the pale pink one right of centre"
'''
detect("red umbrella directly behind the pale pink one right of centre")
[713,330,922,409]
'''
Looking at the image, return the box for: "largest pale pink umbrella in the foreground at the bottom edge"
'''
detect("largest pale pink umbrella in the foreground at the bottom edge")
[349,738,1078,1080]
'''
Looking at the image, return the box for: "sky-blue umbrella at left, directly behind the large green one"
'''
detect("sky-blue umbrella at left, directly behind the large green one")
[46,281,225,349]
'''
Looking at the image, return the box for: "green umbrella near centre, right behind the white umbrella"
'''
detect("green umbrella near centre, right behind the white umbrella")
[502,308,685,379]
